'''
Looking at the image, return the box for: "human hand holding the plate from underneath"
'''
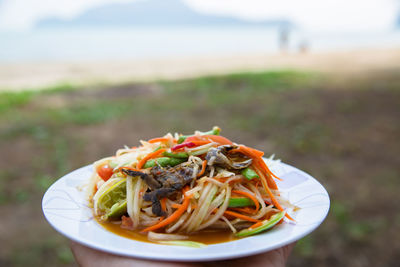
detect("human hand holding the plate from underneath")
[71,242,295,267]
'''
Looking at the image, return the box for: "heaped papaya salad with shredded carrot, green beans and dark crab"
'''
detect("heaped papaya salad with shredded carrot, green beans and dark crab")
[87,127,293,247]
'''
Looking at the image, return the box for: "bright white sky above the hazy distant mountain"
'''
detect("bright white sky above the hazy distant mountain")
[0,0,400,32]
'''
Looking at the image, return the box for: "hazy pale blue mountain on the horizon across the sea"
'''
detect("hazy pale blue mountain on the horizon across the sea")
[36,0,288,27]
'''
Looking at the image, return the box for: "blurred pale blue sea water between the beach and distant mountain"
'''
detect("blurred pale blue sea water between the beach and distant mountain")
[0,27,400,63]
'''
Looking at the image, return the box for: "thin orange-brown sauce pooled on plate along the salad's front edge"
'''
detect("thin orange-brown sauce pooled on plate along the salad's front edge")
[96,218,238,245]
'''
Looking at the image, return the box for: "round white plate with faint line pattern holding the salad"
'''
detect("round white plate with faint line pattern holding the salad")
[42,163,330,261]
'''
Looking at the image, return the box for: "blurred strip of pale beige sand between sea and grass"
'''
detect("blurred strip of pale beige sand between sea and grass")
[0,48,400,91]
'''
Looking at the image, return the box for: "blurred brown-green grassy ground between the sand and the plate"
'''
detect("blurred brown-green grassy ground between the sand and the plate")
[0,70,400,266]
